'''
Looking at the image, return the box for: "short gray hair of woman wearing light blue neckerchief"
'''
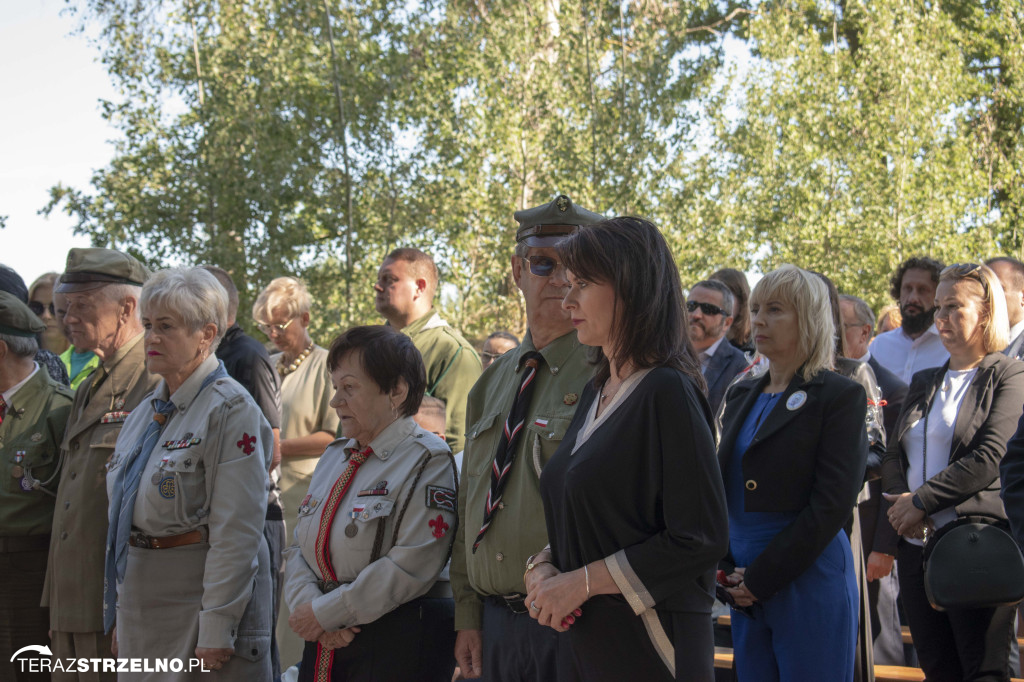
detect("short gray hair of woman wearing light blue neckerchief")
[139,267,227,353]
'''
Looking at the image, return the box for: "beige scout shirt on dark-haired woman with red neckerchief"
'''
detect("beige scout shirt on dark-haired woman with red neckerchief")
[285,417,456,631]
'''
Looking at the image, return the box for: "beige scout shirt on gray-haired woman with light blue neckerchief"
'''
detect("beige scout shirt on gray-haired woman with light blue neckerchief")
[106,356,273,648]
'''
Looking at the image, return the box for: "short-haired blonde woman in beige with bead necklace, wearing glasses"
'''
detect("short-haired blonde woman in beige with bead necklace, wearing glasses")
[253,278,339,669]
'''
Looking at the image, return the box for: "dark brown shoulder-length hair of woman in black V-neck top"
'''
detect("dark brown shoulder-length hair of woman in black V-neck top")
[557,217,708,394]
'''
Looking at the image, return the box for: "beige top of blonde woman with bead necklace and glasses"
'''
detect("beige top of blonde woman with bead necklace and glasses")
[270,345,339,507]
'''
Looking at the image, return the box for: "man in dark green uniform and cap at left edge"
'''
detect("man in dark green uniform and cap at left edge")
[0,292,75,680]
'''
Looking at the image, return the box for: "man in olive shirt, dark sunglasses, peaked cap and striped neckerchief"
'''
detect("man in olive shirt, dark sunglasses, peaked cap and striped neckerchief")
[451,195,603,682]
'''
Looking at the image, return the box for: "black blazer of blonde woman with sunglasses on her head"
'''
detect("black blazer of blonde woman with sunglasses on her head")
[882,352,1024,553]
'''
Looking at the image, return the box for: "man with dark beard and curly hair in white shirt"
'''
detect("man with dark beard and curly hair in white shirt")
[870,257,949,384]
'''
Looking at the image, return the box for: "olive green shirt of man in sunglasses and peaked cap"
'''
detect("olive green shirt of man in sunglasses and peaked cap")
[450,332,593,630]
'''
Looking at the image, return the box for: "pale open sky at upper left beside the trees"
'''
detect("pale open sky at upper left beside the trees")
[0,0,117,285]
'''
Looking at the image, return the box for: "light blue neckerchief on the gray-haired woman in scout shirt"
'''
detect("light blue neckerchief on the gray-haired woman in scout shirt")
[103,361,227,633]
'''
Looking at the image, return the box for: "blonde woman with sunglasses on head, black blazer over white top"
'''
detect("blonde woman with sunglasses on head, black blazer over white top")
[882,263,1024,682]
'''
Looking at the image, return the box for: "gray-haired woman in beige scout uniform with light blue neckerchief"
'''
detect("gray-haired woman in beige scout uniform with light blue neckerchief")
[103,268,273,681]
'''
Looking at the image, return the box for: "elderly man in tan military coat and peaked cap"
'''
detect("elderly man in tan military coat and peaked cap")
[43,249,159,680]
